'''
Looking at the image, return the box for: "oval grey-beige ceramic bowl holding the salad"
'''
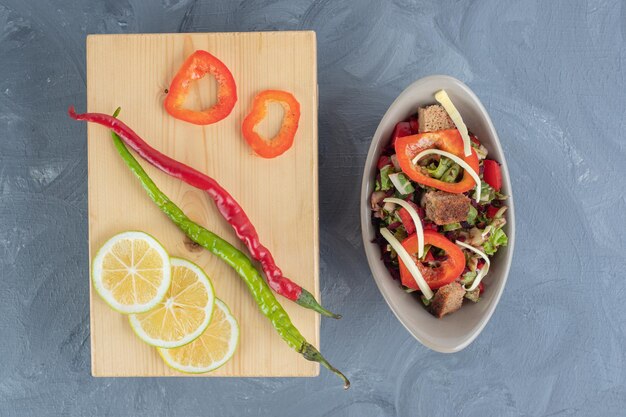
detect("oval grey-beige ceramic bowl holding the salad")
[361,75,515,353]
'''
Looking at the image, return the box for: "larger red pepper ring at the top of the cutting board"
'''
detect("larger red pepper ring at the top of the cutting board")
[163,50,237,125]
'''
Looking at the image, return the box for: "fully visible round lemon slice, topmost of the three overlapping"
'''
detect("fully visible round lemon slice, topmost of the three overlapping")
[92,231,171,314]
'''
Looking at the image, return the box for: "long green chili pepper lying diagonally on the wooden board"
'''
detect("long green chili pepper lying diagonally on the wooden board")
[111,110,350,389]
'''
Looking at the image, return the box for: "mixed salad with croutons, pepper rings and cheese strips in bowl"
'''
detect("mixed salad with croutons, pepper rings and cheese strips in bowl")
[370,90,508,318]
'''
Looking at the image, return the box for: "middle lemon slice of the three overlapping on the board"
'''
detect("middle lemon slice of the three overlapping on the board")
[129,258,215,348]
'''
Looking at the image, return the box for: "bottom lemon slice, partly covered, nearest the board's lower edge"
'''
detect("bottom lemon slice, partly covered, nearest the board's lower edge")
[157,300,239,374]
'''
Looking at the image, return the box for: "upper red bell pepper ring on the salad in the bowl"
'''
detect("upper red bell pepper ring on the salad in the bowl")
[395,129,478,194]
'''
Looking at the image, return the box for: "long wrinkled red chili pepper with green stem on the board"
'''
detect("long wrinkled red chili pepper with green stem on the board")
[69,107,341,318]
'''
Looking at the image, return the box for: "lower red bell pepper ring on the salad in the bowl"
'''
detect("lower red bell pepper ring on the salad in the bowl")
[399,230,465,290]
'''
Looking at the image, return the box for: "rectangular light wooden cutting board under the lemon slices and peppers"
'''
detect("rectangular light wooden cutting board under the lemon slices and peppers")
[87,32,320,376]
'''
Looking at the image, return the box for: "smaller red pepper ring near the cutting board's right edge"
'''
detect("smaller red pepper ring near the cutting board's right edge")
[242,90,300,158]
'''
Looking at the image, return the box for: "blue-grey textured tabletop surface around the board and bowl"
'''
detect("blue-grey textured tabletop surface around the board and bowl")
[0,0,626,417]
